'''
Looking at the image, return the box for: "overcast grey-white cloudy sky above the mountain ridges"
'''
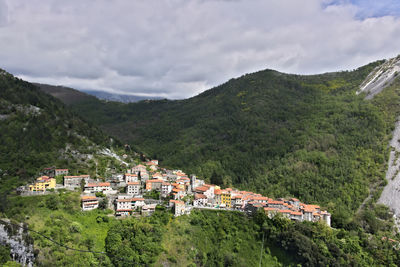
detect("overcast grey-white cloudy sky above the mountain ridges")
[0,0,400,99]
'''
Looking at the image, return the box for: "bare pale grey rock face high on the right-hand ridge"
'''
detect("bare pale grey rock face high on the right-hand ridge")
[357,56,400,99]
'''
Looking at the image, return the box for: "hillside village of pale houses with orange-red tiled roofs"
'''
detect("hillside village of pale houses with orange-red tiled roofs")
[22,160,331,226]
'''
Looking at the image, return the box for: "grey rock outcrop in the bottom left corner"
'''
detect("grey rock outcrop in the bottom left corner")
[0,219,35,267]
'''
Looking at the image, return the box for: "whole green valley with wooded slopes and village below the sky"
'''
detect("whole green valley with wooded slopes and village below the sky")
[0,56,400,266]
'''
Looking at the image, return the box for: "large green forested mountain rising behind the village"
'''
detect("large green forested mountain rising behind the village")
[53,61,399,225]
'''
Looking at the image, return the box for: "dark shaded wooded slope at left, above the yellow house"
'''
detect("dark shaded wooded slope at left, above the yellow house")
[0,70,120,199]
